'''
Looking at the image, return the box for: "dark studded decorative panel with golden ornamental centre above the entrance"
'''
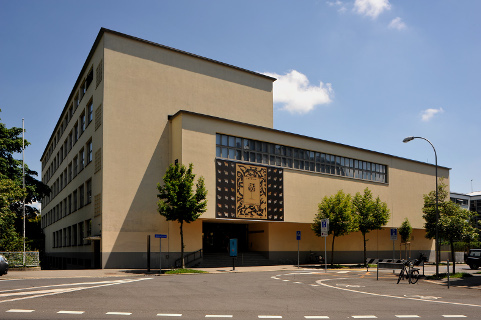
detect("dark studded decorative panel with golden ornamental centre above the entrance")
[216,159,284,221]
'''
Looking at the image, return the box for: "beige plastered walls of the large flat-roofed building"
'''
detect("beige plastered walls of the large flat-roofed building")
[41,29,449,268]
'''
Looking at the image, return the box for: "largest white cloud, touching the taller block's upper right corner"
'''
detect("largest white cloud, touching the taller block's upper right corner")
[264,70,334,114]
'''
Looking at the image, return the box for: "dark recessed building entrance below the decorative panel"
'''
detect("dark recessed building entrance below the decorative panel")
[202,222,248,253]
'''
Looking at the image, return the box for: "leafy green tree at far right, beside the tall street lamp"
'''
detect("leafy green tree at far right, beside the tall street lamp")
[423,179,479,273]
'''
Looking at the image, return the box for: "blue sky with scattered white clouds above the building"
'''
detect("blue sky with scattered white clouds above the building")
[0,0,481,192]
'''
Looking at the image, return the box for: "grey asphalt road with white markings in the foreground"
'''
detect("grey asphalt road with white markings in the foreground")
[0,269,481,319]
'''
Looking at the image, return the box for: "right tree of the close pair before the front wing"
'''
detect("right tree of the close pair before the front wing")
[352,188,390,264]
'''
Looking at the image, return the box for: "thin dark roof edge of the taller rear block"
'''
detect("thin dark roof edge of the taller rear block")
[40,28,277,160]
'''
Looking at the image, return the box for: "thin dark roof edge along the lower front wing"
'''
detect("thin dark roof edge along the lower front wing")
[169,110,451,170]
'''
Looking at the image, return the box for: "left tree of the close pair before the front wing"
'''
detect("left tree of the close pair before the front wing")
[311,190,356,265]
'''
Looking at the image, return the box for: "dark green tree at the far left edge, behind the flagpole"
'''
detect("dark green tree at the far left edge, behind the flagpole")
[0,110,50,251]
